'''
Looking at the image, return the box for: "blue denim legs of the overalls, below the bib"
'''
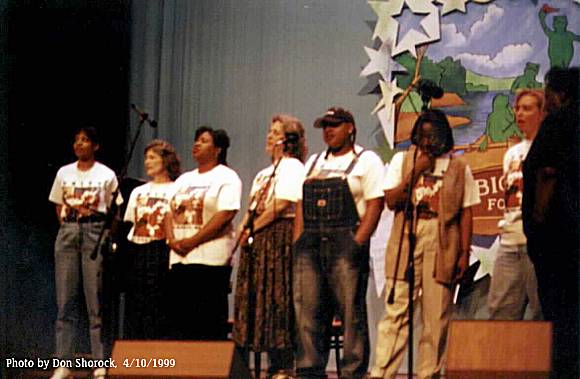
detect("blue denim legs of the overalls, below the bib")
[293,227,369,378]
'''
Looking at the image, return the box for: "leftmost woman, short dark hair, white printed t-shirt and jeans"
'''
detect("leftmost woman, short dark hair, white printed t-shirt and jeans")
[49,127,117,379]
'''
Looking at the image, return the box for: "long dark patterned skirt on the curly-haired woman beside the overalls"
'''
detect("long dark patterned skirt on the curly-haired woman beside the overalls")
[233,219,294,351]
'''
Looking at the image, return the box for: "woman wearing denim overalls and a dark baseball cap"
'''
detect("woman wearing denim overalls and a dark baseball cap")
[293,108,383,378]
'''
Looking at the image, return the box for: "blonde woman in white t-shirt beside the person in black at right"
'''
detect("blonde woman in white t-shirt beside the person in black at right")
[487,89,544,320]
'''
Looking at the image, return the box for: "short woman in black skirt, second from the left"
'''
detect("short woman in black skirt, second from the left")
[125,140,181,340]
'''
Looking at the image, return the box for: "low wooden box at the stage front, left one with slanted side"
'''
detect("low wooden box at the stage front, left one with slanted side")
[107,340,251,379]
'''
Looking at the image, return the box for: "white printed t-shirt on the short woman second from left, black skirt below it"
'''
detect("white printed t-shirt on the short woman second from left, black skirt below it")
[124,182,175,244]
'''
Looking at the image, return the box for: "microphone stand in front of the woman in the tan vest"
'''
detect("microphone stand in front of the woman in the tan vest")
[387,148,419,379]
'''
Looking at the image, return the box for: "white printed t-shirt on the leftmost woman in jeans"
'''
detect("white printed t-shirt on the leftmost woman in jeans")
[48,161,118,220]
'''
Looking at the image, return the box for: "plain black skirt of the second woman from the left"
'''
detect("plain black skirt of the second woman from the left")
[125,241,169,339]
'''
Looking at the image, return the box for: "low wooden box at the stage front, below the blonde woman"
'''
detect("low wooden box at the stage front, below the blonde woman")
[446,320,552,379]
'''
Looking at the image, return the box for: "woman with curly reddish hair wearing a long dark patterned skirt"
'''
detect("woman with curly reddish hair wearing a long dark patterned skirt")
[233,115,306,379]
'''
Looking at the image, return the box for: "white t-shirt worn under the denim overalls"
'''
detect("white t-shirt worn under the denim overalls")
[300,145,384,218]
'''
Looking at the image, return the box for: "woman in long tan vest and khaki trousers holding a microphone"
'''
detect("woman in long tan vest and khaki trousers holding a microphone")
[371,109,480,379]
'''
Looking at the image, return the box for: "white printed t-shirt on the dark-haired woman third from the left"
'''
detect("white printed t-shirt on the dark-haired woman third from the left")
[169,165,242,266]
